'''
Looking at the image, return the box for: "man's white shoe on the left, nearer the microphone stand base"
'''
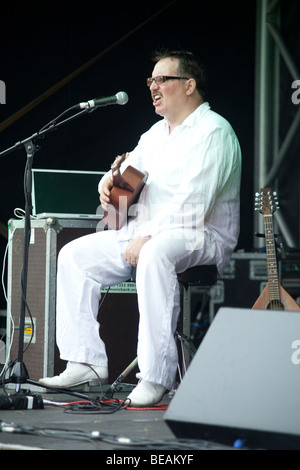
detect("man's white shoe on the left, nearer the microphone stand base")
[39,362,108,388]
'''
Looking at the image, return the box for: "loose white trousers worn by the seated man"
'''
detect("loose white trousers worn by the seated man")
[56,226,216,389]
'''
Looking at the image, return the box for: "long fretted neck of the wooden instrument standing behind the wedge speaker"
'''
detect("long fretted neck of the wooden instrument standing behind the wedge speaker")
[264,214,280,301]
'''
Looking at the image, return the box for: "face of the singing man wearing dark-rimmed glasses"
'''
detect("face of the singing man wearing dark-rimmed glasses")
[150,58,186,120]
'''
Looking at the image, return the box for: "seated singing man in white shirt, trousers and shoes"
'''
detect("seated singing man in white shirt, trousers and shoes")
[40,51,241,407]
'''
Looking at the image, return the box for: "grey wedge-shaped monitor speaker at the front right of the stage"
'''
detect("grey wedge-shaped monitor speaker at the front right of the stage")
[164,307,300,449]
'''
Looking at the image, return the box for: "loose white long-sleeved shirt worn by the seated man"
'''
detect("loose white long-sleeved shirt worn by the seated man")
[99,103,241,273]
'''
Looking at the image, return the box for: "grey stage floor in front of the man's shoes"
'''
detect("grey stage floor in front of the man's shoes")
[0,386,234,454]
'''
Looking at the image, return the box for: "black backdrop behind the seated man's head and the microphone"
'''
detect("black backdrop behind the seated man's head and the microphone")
[0,0,256,308]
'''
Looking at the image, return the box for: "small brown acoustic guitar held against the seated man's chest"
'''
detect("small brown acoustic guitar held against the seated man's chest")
[103,153,148,230]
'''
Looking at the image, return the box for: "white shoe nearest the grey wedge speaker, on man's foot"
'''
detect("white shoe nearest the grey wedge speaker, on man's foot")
[125,380,167,407]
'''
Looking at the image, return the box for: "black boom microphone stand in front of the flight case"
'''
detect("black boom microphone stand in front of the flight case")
[0,108,96,408]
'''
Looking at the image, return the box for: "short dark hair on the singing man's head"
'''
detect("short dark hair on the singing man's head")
[152,49,207,99]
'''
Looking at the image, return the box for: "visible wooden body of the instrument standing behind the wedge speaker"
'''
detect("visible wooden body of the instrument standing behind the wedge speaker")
[252,283,300,312]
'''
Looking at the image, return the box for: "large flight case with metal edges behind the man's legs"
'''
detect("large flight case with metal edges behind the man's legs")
[6,217,138,388]
